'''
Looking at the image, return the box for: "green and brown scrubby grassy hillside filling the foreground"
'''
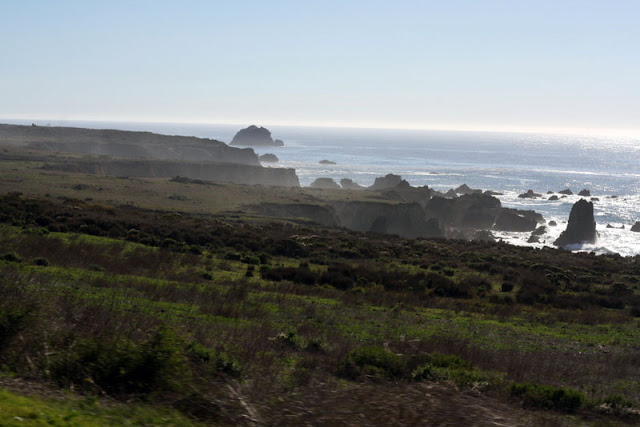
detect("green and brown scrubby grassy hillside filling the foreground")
[0,192,640,425]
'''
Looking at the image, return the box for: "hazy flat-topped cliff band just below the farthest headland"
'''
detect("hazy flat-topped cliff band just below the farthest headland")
[43,158,300,187]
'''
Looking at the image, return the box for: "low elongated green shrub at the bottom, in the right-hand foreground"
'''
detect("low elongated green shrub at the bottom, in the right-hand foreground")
[511,383,586,412]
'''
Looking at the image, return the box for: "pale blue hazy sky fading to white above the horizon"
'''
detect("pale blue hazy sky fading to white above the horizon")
[0,0,640,134]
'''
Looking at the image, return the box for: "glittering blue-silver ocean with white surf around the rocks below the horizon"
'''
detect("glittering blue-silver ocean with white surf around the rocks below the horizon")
[4,121,640,256]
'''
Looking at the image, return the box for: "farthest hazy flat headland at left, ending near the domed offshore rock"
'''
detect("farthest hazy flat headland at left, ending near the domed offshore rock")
[0,125,260,166]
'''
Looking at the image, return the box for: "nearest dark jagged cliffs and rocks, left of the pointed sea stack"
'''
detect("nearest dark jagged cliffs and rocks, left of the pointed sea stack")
[254,187,544,240]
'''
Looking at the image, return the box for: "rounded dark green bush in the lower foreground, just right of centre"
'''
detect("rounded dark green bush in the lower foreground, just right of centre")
[339,346,407,379]
